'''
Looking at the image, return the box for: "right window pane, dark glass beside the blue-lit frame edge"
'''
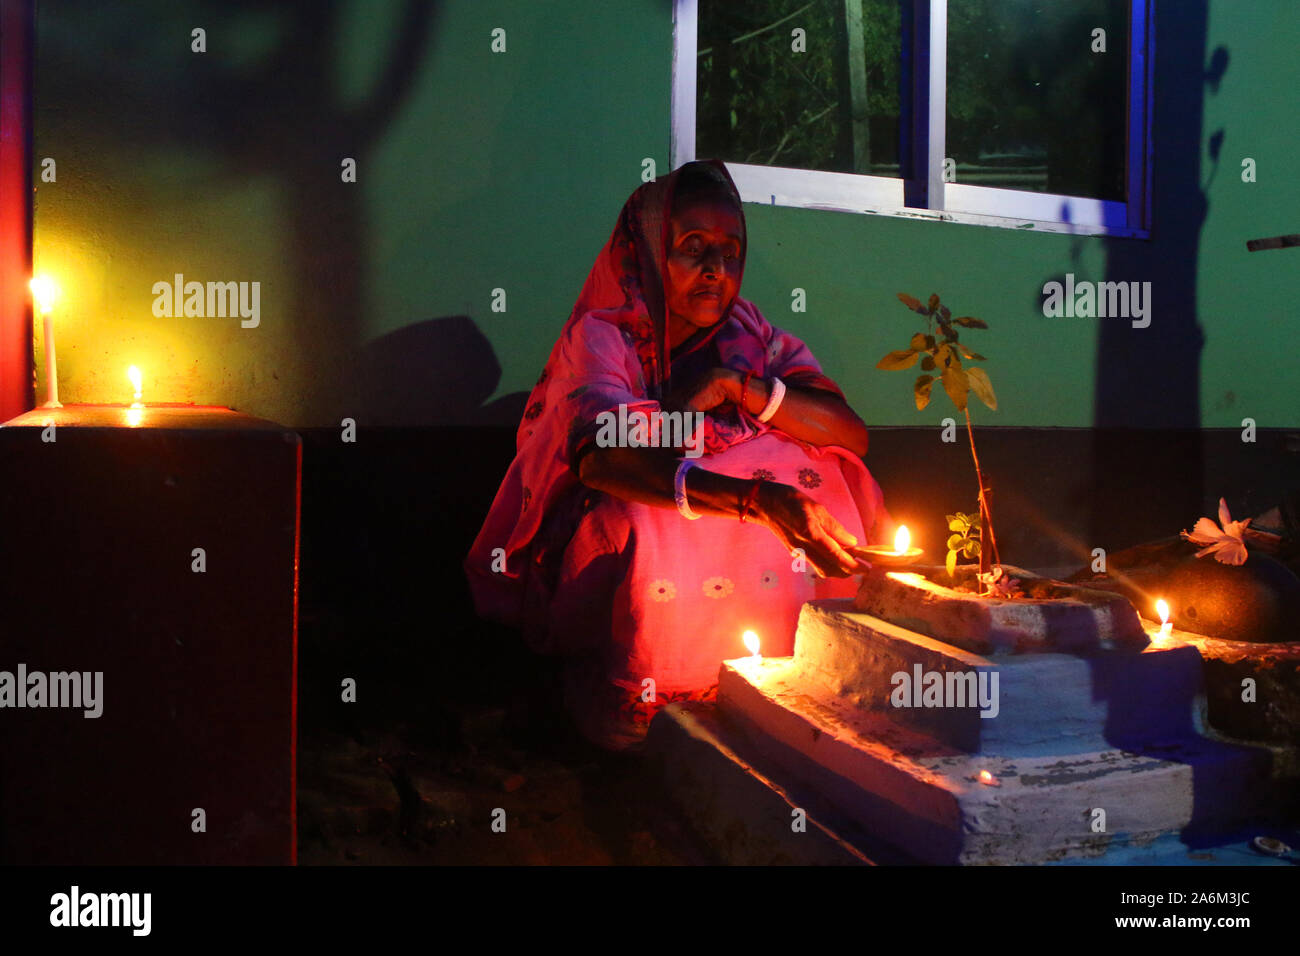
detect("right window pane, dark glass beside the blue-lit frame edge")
[946,0,1128,202]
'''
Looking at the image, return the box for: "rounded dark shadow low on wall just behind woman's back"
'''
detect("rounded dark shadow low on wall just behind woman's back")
[358,315,528,428]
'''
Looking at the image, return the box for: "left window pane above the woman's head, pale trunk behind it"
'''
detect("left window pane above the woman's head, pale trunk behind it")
[696,0,901,177]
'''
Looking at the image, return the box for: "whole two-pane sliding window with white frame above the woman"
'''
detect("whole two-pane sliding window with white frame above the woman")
[672,0,1152,237]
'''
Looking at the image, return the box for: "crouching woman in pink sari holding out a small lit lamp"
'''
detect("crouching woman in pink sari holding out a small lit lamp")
[465,160,892,749]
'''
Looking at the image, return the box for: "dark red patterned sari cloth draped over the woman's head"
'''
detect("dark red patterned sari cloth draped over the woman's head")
[564,159,749,398]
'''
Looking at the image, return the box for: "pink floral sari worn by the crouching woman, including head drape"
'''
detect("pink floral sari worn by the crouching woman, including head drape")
[465,160,891,748]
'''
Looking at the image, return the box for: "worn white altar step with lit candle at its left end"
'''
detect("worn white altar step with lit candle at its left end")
[718,658,1268,864]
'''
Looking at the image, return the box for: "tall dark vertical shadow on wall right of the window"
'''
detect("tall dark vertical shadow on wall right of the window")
[1091,7,1227,548]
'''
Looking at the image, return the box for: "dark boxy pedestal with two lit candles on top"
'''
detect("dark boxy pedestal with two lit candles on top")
[0,406,302,865]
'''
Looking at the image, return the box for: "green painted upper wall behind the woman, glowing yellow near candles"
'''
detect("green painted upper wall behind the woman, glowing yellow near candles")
[35,0,1300,427]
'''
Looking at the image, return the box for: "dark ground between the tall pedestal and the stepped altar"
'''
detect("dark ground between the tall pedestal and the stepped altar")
[298,619,714,865]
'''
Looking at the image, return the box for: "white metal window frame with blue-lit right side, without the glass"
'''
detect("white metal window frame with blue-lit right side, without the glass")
[670,0,1156,239]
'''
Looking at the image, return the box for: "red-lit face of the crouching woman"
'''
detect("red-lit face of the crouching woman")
[664,198,742,345]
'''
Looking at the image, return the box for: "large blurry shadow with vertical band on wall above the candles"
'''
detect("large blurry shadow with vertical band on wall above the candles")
[38,0,442,424]
